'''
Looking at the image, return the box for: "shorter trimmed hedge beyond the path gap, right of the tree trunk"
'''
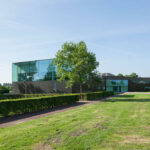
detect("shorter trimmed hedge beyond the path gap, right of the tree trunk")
[82,92,114,100]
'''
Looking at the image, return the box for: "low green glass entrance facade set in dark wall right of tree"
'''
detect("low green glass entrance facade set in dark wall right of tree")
[106,80,128,92]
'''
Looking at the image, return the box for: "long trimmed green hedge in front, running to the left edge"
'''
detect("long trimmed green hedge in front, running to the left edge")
[0,94,79,117]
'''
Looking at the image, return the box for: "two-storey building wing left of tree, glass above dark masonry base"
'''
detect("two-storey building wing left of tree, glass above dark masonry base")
[12,59,72,94]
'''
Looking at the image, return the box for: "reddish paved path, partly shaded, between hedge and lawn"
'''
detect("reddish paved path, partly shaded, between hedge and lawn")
[0,95,119,128]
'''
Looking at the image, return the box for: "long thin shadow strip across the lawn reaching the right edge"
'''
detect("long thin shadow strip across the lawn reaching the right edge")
[105,99,150,102]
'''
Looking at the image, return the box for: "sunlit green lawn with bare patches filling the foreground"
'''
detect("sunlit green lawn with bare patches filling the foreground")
[0,94,150,150]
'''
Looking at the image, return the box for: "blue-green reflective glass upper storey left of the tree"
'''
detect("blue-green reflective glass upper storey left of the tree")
[12,59,56,82]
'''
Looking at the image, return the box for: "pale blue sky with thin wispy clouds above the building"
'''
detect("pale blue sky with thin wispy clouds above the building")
[0,0,150,83]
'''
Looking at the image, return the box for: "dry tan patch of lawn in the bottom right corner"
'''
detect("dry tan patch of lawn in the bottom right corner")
[122,135,150,144]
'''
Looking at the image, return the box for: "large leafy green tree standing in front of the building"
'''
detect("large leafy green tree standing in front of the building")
[53,41,99,93]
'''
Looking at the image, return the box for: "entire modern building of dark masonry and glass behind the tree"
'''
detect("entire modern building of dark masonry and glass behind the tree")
[12,59,150,94]
